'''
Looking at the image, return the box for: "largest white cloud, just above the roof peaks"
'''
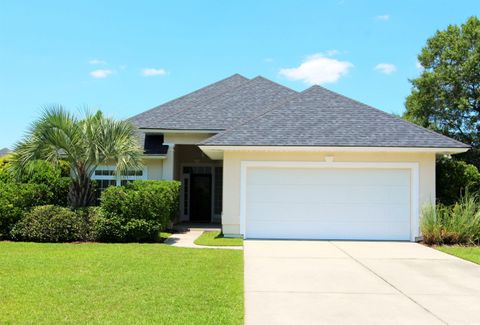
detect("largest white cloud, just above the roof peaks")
[280,50,353,85]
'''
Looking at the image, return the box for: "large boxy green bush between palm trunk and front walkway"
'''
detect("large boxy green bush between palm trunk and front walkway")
[93,181,180,242]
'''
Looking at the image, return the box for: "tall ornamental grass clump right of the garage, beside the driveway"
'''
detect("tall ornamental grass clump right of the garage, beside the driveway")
[420,193,480,245]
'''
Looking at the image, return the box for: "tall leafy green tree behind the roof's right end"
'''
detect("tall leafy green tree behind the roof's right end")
[405,16,480,148]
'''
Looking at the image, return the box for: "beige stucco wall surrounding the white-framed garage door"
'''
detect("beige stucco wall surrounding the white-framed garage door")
[222,151,435,236]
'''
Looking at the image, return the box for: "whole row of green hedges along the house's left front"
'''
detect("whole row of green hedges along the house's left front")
[0,181,180,242]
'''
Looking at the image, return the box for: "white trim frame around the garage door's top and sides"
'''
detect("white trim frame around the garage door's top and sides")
[240,160,420,241]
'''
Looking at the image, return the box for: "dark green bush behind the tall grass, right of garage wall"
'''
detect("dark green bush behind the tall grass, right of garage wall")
[436,157,480,205]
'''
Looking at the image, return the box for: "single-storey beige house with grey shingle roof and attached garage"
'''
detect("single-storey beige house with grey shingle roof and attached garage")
[97,74,469,241]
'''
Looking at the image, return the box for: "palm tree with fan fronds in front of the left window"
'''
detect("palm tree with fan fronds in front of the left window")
[11,106,142,208]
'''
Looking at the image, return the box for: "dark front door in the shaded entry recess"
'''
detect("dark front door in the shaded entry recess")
[190,174,212,222]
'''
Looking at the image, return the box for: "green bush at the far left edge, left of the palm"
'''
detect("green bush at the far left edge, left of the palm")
[0,182,51,239]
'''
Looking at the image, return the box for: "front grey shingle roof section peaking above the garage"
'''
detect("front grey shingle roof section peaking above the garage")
[201,86,468,148]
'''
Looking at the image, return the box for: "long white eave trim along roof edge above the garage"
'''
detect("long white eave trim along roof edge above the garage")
[199,145,470,153]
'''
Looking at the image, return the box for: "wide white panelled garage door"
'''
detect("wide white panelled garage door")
[244,167,411,240]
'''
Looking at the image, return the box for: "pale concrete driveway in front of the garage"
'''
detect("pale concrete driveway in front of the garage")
[244,240,480,324]
